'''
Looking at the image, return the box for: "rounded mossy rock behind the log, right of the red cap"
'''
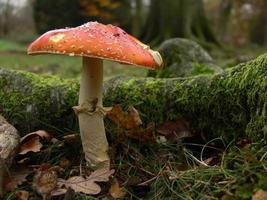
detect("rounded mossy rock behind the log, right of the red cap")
[148,38,223,78]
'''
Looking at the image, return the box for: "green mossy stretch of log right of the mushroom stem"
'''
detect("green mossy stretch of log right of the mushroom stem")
[106,55,267,140]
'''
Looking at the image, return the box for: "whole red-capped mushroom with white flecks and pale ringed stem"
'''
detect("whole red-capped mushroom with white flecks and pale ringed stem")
[28,22,163,168]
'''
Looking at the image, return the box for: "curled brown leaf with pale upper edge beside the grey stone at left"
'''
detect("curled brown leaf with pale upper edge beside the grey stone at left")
[18,130,52,155]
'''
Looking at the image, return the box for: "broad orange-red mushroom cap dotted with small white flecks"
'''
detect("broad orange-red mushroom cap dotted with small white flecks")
[28,22,163,69]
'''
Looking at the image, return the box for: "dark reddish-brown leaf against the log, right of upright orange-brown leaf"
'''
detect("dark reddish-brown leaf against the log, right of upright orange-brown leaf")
[157,119,192,141]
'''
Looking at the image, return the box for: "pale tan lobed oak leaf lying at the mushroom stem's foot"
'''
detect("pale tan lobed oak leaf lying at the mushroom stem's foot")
[60,168,114,194]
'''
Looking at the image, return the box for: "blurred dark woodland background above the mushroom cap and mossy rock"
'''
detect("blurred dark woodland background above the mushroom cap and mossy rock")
[0,0,267,78]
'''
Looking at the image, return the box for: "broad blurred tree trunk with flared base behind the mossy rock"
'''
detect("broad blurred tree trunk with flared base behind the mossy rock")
[142,0,218,45]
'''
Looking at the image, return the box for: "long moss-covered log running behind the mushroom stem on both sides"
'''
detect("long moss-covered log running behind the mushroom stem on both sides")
[0,54,267,141]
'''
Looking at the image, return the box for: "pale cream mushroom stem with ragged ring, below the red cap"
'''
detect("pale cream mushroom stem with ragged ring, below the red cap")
[76,57,110,168]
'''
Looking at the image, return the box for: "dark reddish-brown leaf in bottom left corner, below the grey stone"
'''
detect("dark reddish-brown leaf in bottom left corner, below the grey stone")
[4,169,32,192]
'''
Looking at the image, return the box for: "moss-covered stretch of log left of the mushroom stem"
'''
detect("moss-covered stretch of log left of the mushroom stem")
[0,70,78,134]
